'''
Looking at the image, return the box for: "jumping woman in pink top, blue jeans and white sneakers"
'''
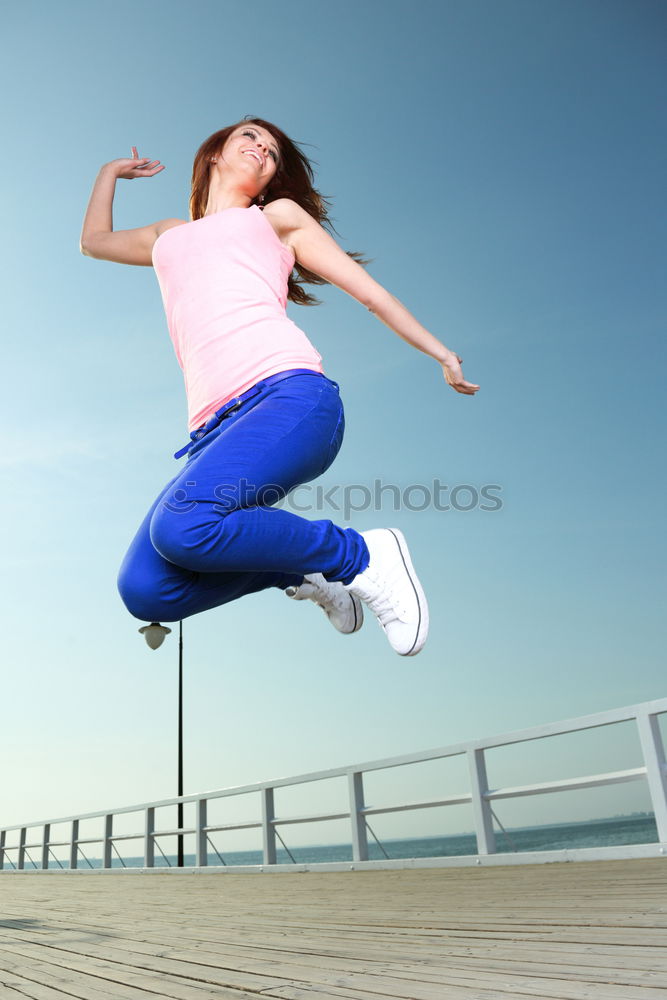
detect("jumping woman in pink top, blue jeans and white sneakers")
[81,117,479,656]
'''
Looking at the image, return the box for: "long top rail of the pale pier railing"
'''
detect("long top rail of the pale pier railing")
[0,698,667,839]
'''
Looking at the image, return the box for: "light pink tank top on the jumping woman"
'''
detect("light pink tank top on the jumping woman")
[153,205,323,430]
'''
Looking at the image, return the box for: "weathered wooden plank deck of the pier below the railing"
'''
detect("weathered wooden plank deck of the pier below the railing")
[0,858,667,1000]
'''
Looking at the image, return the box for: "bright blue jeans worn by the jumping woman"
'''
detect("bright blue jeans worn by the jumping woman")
[118,372,369,622]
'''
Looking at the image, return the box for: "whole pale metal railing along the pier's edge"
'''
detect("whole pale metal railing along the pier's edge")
[0,698,667,872]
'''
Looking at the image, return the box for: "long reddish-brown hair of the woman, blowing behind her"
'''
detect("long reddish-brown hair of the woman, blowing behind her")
[190,115,373,306]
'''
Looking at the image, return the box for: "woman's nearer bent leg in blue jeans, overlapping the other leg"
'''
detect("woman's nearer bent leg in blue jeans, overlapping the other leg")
[150,376,369,583]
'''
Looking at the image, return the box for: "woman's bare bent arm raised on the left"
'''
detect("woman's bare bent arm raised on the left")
[79,147,172,267]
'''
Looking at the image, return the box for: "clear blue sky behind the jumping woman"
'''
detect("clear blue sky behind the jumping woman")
[0,0,667,844]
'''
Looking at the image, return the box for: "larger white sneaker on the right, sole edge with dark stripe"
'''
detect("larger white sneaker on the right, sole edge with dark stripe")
[344,528,428,656]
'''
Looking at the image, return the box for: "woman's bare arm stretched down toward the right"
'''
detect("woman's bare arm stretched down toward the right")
[271,198,479,396]
